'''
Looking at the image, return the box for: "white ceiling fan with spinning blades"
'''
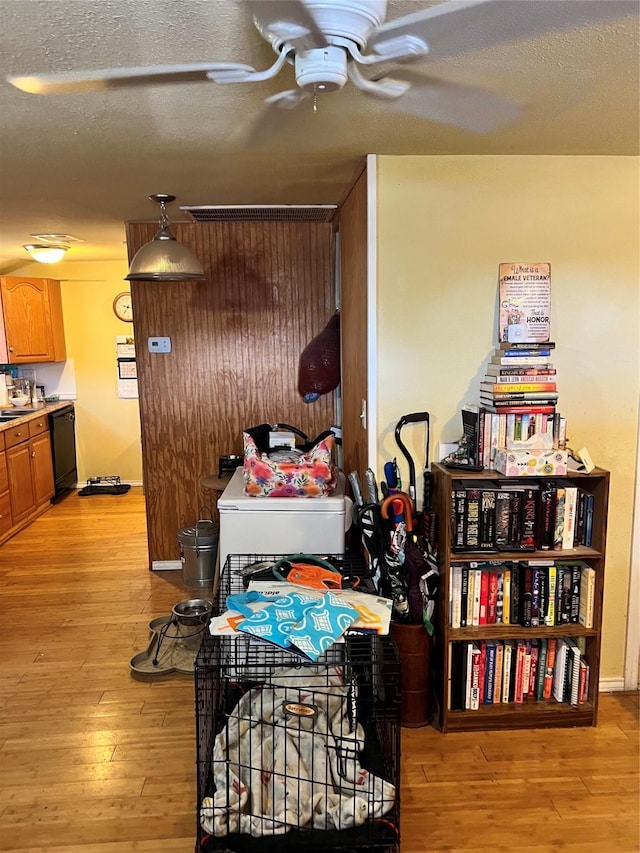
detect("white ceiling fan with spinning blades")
[7,0,638,133]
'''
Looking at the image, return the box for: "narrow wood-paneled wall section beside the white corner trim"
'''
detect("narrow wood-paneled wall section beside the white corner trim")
[338,171,368,477]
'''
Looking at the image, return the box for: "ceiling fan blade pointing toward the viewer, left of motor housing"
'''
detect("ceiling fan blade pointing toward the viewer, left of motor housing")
[245,0,327,50]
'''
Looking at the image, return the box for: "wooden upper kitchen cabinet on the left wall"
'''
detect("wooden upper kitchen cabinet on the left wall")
[0,276,67,364]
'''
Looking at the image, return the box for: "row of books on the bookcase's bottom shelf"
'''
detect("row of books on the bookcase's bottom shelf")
[448,637,589,711]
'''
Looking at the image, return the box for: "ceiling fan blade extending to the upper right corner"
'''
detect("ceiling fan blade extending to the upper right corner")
[368,0,638,60]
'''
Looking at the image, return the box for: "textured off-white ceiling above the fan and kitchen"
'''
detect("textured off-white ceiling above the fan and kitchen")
[0,0,639,272]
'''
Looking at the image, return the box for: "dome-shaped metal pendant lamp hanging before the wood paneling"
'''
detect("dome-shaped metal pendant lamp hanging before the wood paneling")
[125,193,205,281]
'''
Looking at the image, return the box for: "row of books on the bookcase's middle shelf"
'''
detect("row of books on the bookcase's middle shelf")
[449,560,596,628]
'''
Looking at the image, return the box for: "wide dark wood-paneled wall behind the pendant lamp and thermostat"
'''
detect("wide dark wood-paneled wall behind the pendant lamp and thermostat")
[127,222,335,563]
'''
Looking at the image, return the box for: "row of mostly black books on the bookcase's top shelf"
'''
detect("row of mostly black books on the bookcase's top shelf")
[451,479,594,552]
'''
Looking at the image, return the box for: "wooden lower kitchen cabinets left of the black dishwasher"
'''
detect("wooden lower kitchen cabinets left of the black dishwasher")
[0,418,54,541]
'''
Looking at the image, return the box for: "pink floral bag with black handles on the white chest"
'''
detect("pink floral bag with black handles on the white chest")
[242,424,338,498]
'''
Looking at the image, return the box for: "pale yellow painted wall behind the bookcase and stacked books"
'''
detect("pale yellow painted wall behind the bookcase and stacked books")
[377,156,640,679]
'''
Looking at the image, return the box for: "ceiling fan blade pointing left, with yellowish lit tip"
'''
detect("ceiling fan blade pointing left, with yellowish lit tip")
[7,62,255,95]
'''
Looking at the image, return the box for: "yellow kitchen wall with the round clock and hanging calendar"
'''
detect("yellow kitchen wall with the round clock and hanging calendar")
[13,259,142,483]
